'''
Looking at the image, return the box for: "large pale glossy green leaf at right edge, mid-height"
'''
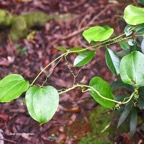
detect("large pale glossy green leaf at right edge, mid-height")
[120,51,144,87]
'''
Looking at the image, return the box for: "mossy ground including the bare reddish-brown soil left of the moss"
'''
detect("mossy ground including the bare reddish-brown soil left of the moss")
[64,103,129,144]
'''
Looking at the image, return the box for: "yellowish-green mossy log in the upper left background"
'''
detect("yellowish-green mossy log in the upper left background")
[0,9,53,41]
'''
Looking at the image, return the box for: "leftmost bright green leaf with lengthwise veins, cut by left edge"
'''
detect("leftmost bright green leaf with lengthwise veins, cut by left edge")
[0,74,29,102]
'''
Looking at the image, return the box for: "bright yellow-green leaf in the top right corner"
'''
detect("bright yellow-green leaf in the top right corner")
[124,5,144,25]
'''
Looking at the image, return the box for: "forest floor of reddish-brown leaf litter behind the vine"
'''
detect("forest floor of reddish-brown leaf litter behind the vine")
[0,0,144,144]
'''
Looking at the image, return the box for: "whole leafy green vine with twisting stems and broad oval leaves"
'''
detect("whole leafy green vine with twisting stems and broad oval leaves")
[0,5,144,135]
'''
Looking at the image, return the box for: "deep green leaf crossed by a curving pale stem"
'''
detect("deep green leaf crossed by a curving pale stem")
[89,77,115,108]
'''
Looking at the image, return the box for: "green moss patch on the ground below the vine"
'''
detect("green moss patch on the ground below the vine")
[79,106,113,144]
